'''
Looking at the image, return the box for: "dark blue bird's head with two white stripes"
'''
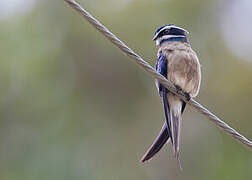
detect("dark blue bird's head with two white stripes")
[153,24,189,46]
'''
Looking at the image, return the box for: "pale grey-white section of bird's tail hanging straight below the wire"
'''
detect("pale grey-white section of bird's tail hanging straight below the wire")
[167,94,184,169]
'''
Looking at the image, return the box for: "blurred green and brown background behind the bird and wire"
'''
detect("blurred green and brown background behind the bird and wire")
[0,0,252,180]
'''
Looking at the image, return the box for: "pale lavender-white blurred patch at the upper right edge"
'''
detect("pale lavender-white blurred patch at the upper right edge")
[220,0,252,62]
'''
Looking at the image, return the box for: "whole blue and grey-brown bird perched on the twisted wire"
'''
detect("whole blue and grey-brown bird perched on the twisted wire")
[142,24,201,167]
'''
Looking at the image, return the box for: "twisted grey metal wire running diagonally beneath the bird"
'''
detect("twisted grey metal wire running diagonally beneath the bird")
[64,0,252,150]
